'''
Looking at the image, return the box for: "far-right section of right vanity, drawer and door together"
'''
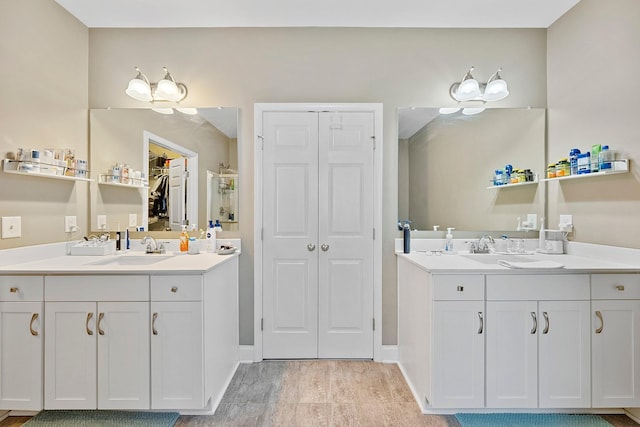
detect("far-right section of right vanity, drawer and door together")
[591,274,640,408]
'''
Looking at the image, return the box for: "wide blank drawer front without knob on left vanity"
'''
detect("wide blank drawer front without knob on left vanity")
[44,276,149,301]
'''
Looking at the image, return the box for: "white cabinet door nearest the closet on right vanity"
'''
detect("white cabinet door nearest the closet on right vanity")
[431,301,484,408]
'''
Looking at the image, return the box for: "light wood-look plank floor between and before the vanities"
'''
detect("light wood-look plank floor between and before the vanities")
[0,360,638,427]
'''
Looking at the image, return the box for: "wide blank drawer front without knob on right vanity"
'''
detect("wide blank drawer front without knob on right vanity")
[487,274,590,301]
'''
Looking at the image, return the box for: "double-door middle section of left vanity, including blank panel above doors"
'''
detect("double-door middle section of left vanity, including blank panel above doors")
[44,276,150,409]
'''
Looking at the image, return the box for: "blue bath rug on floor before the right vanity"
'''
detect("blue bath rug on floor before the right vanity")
[456,413,611,427]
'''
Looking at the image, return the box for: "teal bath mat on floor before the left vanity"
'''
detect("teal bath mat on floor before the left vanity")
[23,411,180,427]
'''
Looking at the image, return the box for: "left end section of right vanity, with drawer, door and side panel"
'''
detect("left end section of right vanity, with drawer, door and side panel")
[398,258,484,408]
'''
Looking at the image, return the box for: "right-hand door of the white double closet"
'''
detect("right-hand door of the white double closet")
[318,112,374,358]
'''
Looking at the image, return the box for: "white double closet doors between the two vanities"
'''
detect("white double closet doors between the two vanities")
[262,111,375,359]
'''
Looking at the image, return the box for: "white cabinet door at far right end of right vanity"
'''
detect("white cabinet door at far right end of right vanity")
[591,300,640,408]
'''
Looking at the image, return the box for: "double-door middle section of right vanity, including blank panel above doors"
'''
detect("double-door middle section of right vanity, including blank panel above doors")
[486,274,591,408]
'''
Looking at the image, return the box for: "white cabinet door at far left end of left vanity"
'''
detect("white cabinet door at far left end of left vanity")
[0,302,43,411]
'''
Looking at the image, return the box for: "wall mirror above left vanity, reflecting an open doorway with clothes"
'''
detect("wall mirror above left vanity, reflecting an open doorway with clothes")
[90,107,240,234]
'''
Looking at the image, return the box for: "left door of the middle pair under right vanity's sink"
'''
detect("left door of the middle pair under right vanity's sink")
[486,301,540,408]
